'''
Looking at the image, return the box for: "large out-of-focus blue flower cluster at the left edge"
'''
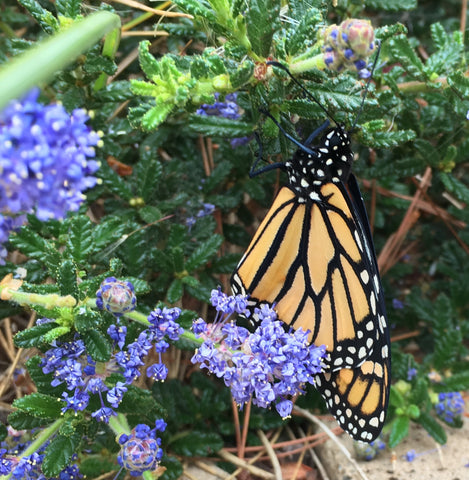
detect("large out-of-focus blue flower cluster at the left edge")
[0,89,101,258]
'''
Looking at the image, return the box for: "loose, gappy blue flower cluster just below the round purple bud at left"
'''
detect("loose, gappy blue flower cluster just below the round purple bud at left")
[40,287,184,423]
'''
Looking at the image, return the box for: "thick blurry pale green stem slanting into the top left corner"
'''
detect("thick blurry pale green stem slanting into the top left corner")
[0,11,120,110]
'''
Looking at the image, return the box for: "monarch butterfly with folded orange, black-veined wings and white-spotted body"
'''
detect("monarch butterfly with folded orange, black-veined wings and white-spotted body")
[231,63,391,442]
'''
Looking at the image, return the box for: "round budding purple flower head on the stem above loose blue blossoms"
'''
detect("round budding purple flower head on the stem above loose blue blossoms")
[96,277,137,317]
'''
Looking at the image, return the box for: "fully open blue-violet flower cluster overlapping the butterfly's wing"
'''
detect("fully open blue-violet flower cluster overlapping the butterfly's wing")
[192,290,326,418]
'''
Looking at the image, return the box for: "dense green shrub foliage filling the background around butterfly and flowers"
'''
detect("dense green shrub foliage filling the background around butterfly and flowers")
[0,0,469,478]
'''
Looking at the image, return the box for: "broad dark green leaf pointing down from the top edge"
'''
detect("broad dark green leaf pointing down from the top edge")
[245,0,280,58]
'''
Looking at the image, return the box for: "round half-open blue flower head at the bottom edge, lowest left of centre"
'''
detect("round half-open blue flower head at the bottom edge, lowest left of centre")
[117,420,166,477]
